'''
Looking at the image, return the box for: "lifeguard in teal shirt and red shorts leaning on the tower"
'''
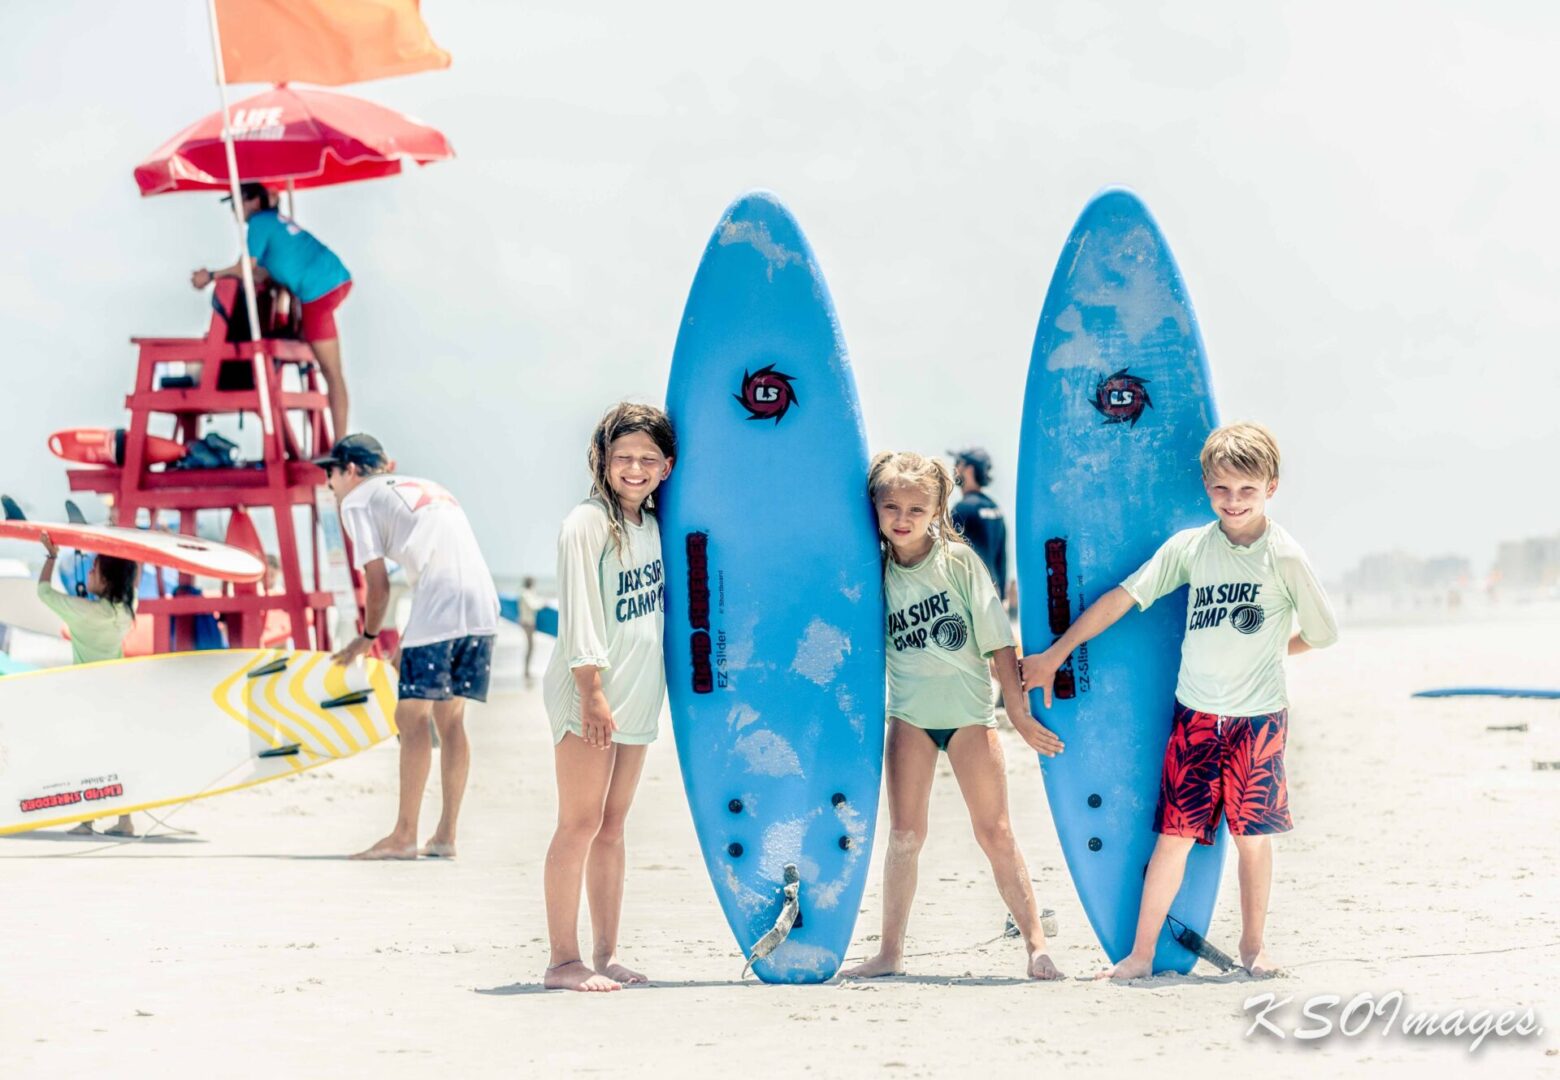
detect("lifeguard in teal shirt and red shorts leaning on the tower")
[190,184,353,437]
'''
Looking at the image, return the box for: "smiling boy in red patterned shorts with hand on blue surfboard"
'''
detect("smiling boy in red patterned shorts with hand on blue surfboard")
[1023,423,1338,979]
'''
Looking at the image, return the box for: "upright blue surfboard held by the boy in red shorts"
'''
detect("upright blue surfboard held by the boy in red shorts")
[1016,189,1225,972]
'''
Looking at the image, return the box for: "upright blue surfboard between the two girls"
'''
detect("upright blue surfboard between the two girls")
[658,192,883,983]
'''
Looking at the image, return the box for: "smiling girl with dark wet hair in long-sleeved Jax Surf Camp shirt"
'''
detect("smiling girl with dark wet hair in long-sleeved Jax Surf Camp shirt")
[543,403,677,991]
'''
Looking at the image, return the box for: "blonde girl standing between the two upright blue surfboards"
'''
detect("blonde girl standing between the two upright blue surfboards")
[844,454,1062,980]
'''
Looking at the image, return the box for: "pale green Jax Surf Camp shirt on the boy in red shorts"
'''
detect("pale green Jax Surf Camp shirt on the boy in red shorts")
[1122,520,1338,716]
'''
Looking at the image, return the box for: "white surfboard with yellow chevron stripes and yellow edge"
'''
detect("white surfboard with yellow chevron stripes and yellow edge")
[0,649,395,835]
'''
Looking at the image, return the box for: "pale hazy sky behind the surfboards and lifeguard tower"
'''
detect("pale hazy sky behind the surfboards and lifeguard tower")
[0,0,1560,576]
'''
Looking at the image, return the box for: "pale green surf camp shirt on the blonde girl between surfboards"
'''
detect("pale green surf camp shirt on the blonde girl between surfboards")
[883,540,1012,729]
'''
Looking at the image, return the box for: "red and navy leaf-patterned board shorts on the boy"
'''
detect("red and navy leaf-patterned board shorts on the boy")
[1154,701,1295,844]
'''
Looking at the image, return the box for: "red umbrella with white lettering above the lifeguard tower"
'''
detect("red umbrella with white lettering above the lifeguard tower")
[136,86,456,195]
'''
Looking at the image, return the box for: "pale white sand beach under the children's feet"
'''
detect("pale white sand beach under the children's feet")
[0,609,1560,1078]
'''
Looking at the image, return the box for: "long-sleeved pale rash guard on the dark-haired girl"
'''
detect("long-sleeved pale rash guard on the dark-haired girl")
[543,499,666,744]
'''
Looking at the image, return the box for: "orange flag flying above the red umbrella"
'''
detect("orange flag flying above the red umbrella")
[217,0,449,86]
